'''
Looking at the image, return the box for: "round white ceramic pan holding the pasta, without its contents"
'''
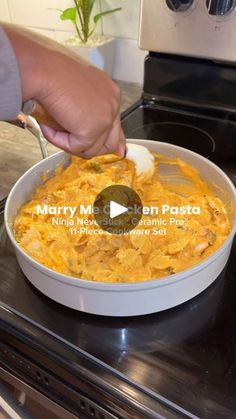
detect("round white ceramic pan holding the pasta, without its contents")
[5,140,236,316]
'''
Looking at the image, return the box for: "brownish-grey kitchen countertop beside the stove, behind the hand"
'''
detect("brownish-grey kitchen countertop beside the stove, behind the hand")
[0,82,142,200]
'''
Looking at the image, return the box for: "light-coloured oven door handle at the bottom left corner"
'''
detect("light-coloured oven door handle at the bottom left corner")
[0,382,33,419]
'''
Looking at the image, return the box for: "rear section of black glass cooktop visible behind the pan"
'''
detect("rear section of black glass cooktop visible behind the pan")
[123,103,236,184]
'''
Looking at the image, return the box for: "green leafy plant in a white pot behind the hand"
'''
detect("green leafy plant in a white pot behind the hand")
[57,0,121,75]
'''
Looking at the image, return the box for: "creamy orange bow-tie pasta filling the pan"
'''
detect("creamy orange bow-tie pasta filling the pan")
[14,154,231,283]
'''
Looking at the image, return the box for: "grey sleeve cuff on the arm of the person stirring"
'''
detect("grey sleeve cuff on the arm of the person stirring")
[0,27,22,121]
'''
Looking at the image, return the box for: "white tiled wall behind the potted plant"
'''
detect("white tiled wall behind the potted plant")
[0,0,146,83]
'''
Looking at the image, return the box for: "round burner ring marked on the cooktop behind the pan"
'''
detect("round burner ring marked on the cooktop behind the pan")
[132,122,215,157]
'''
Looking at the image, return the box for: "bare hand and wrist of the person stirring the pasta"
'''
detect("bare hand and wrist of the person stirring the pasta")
[3,24,125,158]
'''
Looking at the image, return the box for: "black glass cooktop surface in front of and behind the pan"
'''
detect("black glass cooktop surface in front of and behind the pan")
[0,105,236,419]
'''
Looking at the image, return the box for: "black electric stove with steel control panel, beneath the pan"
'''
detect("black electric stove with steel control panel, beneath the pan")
[0,0,236,419]
